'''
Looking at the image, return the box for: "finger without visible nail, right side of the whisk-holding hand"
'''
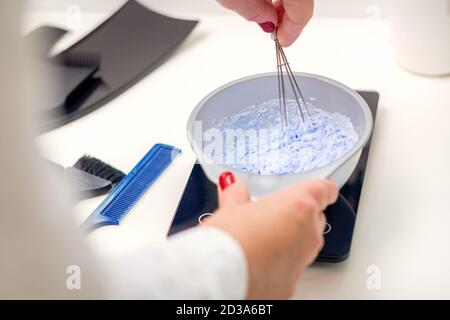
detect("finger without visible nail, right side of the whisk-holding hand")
[277,0,314,47]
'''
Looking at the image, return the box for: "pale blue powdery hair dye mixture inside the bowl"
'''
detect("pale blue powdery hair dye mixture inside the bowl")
[210,99,358,175]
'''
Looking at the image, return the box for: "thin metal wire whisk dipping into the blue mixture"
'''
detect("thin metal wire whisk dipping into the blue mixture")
[272,30,311,127]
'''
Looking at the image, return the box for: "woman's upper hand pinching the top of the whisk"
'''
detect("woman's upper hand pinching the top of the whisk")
[218,0,314,47]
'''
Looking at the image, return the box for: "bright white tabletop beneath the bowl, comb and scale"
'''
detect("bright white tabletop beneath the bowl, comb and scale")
[26,3,450,299]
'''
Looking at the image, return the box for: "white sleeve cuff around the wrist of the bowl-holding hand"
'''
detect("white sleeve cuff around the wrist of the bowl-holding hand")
[104,227,248,299]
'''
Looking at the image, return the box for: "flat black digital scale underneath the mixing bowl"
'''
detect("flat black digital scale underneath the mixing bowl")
[169,91,379,262]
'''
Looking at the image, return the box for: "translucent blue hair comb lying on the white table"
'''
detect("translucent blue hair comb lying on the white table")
[81,144,181,232]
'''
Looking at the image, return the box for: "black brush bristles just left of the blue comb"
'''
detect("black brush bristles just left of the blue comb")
[73,155,125,184]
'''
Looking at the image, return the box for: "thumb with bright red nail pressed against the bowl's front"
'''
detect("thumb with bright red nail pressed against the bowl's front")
[217,172,250,207]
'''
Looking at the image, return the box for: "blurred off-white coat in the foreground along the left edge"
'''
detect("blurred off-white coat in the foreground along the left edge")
[0,1,101,299]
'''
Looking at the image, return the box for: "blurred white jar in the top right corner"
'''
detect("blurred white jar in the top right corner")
[387,0,450,76]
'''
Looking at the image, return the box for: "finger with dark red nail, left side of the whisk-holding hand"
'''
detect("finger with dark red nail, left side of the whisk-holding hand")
[219,0,278,25]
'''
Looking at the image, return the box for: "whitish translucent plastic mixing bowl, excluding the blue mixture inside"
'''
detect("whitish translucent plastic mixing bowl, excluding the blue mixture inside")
[187,73,373,198]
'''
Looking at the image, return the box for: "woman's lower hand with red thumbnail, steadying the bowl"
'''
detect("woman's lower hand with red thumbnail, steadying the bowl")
[204,173,338,299]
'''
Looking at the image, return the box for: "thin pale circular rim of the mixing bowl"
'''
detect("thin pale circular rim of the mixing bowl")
[187,72,373,177]
